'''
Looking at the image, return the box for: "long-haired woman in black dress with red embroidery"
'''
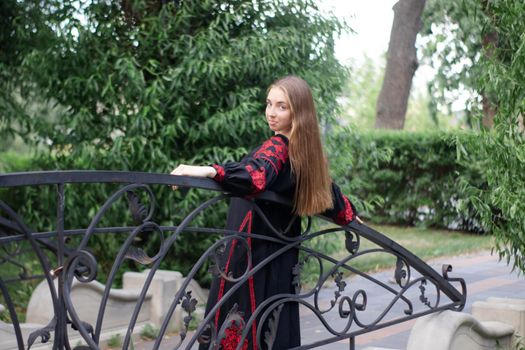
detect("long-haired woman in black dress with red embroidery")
[172,76,358,349]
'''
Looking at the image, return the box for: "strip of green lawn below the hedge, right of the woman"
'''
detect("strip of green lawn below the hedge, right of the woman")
[302,225,493,285]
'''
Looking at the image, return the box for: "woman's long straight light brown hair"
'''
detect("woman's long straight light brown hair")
[268,76,333,216]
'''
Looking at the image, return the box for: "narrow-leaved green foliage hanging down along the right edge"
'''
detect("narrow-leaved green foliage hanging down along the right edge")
[467,0,525,272]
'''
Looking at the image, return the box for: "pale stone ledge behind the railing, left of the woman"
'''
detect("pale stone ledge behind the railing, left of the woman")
[0,270,208,350]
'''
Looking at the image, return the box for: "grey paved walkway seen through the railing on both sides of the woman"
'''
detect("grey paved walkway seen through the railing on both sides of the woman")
[135,251,525,350]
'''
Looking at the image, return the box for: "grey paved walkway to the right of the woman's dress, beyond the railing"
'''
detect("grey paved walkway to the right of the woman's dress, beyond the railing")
[302,251,525,350]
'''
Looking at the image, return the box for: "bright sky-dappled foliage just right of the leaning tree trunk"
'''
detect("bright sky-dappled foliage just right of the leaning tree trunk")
[419,0,484,126]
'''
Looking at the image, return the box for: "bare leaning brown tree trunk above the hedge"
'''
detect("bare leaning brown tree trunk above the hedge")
[375,0,426,129]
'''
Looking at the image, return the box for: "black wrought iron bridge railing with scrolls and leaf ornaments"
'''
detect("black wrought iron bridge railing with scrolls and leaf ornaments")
[0,171,466,349]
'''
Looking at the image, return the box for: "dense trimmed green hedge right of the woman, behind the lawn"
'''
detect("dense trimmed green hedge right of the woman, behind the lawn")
[330,129,485,232]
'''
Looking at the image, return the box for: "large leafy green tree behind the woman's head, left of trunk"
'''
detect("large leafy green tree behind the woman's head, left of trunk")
[0,0,345,282]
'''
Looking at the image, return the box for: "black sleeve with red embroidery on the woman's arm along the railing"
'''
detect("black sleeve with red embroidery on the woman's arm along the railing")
[212,136,288,196]
